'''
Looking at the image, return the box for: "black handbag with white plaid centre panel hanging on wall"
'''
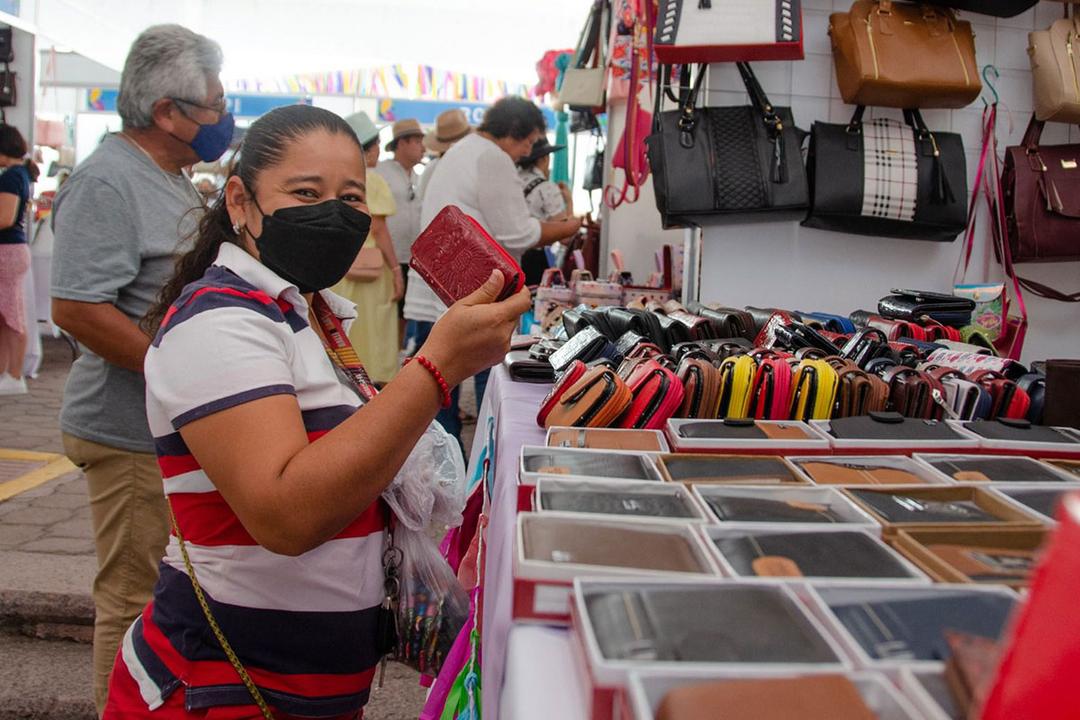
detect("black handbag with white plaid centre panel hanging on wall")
[802,107,968,242]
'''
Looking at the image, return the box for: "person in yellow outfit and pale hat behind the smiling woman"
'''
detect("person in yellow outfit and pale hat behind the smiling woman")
[332,112,405,384]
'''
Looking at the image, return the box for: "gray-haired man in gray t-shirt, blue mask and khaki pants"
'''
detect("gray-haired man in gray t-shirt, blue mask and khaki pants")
[52,25,233,714]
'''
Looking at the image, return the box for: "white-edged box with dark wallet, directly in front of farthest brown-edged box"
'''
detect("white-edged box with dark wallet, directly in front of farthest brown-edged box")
[693,485,881,526]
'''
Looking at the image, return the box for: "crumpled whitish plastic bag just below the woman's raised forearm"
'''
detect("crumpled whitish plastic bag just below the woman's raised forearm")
[382,422,465,531]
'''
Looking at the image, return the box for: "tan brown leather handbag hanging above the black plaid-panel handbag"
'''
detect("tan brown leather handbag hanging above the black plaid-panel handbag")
[828,0,983,108]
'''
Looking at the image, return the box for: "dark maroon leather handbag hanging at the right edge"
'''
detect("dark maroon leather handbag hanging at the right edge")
[1001,117,1080,266]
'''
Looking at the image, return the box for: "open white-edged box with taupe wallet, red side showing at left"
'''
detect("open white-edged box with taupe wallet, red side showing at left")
[514,513,719,623]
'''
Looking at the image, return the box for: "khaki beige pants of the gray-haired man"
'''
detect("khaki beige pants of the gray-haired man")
[64,433,170,716]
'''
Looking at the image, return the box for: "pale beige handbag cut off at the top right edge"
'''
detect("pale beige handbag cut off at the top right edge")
[1027,14,1080,123]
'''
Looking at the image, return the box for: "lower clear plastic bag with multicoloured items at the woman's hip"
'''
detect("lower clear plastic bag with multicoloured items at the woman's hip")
[387,525,469,677]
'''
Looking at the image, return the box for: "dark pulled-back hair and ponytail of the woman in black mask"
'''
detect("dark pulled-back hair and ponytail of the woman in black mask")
[141,105,361,335]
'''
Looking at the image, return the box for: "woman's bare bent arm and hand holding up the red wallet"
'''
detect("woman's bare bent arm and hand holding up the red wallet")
[180,273,529,555]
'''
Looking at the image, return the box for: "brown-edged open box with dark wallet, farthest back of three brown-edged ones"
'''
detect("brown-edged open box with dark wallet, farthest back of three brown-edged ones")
[657,453,810,486]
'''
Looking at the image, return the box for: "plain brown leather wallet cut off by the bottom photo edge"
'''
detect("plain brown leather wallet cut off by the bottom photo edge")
[657,675,877,720]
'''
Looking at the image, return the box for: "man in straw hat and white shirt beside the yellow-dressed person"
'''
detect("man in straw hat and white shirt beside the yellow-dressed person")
[376,118,423,338]
